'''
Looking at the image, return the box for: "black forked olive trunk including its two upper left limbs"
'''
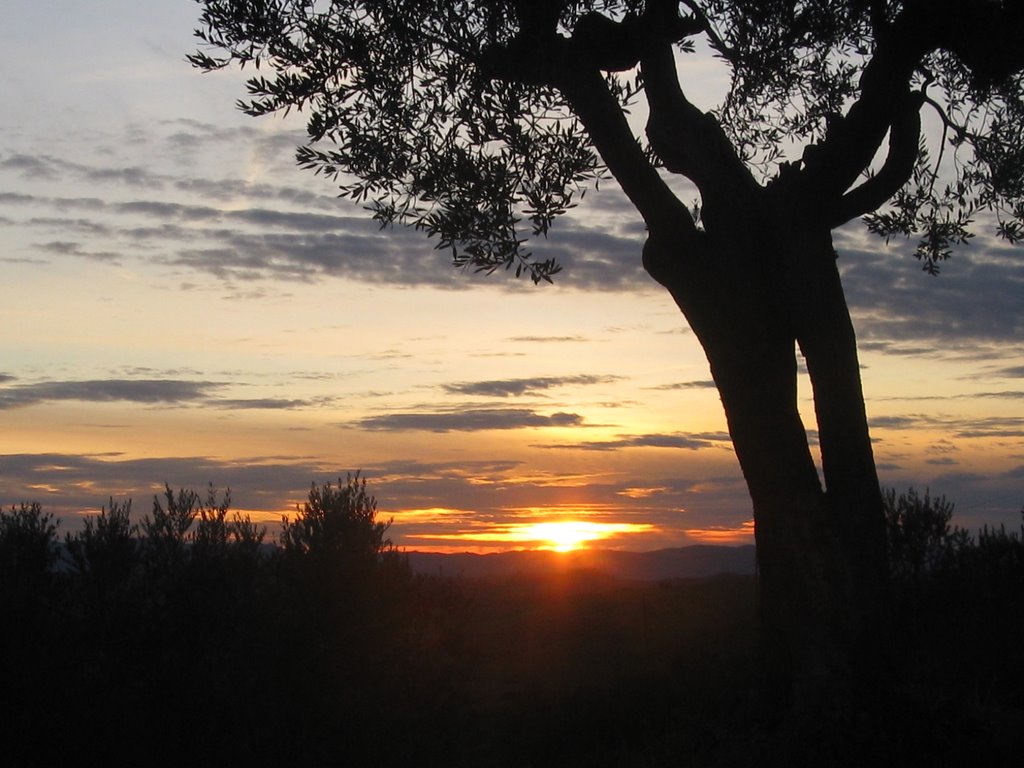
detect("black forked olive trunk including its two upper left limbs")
[557,39,886,695]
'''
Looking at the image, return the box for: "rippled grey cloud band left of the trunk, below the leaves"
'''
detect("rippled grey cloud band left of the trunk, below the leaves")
[0,140,652,291]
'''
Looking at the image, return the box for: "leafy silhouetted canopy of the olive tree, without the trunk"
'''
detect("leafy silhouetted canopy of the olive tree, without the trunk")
[189,0,1024,282]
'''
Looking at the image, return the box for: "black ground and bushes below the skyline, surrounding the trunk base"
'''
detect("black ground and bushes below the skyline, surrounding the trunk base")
[0,477,1024,766]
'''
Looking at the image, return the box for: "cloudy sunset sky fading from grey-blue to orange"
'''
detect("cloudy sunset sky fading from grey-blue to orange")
[0,0,1024,551]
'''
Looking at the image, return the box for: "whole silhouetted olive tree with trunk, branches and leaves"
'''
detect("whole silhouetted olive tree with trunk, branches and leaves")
[191,0,1024,696]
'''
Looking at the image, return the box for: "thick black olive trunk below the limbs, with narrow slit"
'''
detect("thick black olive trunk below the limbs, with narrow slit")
[644,220,885,708]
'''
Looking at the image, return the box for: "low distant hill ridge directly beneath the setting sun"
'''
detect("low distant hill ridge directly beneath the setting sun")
[406,545,755,581]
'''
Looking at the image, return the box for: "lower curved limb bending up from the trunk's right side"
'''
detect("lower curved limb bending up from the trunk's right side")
[828,93,924,227]
